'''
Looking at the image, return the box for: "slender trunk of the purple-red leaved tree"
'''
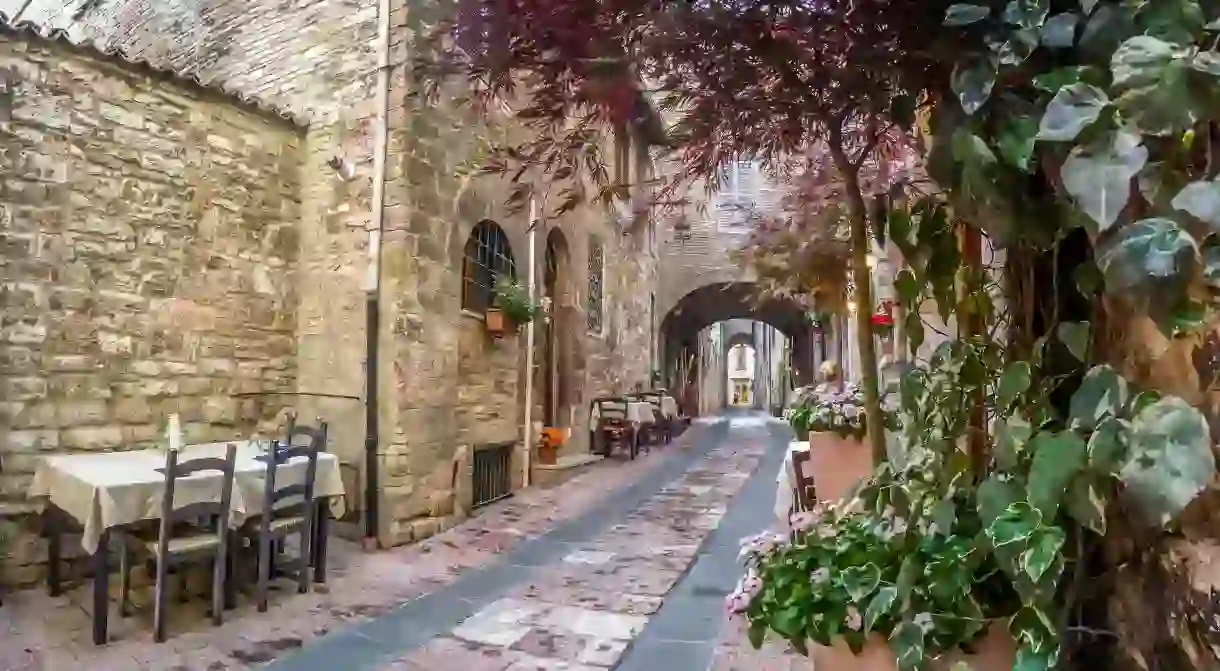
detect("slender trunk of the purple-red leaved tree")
[844,171,886,465]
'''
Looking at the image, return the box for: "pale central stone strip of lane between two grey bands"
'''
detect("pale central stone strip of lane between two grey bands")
[388,417,773,671]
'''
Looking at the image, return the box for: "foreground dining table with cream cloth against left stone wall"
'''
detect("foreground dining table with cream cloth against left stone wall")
[29,440,344,645]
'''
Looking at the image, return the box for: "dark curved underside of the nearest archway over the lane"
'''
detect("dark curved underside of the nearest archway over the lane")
[662,282,810,342]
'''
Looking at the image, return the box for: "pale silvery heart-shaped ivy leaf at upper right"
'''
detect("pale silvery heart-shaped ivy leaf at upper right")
[1061,131,1148,233]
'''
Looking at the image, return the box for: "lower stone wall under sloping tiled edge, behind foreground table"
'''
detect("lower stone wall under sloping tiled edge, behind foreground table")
[0,35,301,500]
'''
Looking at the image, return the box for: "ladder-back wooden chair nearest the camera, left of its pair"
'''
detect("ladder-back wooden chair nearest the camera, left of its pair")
[118,443,237,643]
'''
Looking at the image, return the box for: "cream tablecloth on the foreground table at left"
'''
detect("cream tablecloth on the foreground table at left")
[29,440,344,554]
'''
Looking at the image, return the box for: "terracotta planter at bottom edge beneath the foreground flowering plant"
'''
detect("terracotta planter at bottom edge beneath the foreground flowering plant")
[809,621,1016,671]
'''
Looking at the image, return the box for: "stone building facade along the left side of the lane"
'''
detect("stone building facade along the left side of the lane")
[0,0,658,583]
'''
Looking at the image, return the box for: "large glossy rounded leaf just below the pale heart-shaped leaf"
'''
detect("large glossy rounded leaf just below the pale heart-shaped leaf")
[1098,217,1198,292]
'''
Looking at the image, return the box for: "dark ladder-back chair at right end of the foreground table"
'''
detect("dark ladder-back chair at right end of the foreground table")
[243,415,327,612]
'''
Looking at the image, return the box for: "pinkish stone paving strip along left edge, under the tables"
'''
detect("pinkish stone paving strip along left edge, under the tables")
[0,425,716,671]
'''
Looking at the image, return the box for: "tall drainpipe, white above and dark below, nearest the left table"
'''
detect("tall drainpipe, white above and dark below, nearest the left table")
[364,0,390,550]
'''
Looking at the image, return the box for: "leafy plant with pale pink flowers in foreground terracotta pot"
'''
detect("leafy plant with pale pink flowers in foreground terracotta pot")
[726,485,1013,669]
